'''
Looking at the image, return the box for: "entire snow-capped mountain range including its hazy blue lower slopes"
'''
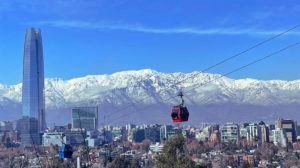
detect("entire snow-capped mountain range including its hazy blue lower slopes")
[0,69,300,123]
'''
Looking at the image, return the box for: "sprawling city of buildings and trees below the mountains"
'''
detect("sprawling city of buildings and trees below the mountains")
[1,107,300,167]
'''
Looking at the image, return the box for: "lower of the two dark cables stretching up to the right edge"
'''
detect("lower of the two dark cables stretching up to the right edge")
[111,41,300,123]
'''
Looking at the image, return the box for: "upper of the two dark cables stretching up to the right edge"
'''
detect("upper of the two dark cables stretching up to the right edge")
[108,24,300,121]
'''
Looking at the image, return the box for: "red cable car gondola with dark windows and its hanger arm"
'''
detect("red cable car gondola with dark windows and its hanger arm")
[171,92,189,122]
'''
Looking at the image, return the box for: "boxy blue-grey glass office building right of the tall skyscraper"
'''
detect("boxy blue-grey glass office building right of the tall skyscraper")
[72,107,98,130]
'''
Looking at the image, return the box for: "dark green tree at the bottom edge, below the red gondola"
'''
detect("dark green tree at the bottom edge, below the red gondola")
[156,134,196,168]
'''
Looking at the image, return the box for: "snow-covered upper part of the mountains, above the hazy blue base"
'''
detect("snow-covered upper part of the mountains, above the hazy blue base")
[0,69,300,125]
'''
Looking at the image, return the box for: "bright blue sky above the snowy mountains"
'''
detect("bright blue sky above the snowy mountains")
[0,0,300,84]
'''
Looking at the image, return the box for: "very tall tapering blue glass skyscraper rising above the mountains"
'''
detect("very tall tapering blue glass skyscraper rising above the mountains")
[21,28,46,145]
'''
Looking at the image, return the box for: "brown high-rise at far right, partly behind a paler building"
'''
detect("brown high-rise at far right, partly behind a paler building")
[275,119,297,143]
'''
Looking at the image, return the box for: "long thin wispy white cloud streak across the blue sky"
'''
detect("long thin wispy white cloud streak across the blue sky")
[35,21,300,35]
